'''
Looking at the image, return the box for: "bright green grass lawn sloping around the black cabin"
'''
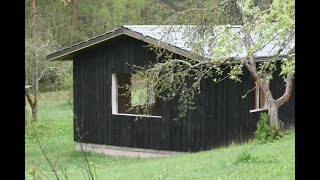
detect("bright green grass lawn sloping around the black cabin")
[25,92,295,179]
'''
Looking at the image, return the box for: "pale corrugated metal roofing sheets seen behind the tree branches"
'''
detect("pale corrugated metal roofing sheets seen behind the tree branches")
[123,25,294,58]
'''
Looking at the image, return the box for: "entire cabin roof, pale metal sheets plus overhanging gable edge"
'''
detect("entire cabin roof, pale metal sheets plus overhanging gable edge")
[47,25,295,60]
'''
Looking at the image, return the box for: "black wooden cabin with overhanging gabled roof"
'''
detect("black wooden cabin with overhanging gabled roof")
[47,25,295,156]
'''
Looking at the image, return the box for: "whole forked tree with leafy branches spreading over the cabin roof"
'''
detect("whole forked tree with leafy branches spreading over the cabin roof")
[131,0,295,130]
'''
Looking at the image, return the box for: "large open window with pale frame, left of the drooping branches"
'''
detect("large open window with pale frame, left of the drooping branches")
[111,73,161,117]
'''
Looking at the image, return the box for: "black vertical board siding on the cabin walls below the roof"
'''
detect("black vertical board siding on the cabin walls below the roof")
[73,36,294,151]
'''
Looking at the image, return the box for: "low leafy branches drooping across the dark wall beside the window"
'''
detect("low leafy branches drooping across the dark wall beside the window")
[127,45,242,119]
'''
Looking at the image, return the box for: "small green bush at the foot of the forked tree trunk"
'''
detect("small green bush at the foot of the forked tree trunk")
[255,113,283,143]
